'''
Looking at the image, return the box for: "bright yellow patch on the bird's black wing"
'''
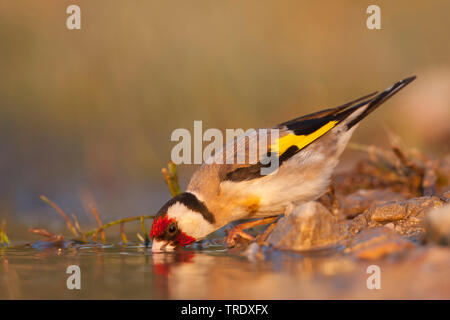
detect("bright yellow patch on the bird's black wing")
[270,121,338,155]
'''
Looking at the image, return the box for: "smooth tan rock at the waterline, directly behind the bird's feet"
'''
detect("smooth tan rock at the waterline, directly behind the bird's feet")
[267,201,346,251]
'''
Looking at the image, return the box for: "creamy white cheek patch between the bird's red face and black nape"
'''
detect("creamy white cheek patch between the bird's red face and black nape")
[167,202,215,240]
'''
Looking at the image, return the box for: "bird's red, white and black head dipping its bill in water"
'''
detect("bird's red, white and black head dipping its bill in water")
[150,192,215,252]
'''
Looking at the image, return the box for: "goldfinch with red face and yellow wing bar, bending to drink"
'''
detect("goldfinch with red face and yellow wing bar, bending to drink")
[150,76,415,252]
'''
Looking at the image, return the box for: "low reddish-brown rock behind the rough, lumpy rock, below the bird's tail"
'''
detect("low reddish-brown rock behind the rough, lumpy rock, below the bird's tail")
[339,189,406,218]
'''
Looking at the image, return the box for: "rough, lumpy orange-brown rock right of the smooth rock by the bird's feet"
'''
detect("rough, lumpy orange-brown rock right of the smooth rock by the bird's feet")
[349,197,444,237]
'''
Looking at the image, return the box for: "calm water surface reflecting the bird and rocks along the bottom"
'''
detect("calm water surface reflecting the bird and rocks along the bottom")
[0,240,450,299]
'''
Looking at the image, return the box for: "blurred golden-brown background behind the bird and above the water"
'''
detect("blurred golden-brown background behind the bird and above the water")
[0,0,450,231]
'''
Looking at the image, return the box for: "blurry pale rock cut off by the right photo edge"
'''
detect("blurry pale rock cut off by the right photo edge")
[424,204,450,246]
